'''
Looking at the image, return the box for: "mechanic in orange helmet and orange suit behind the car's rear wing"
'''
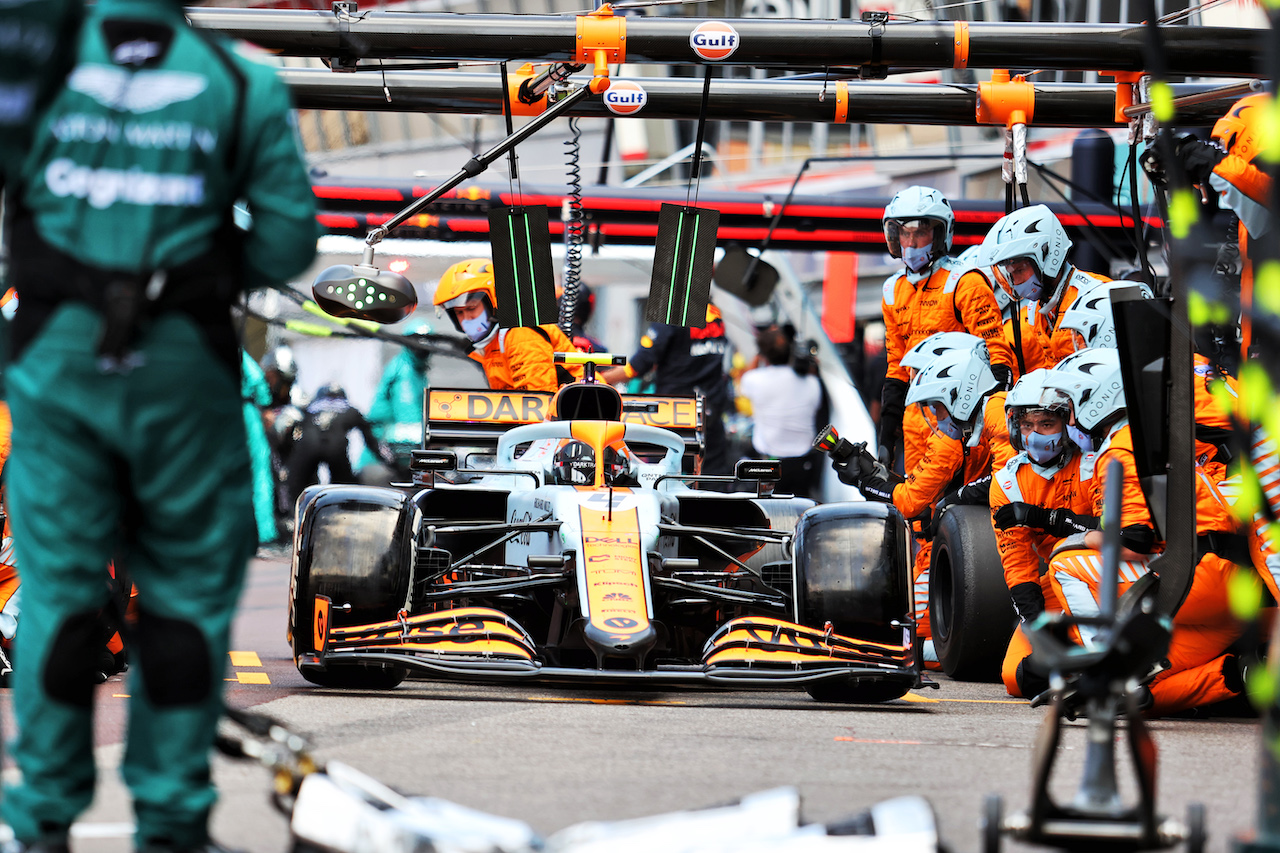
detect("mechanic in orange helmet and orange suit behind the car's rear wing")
[435,257,577,391]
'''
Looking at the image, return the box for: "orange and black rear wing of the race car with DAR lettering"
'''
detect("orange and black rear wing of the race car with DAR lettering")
[422,388,703,461]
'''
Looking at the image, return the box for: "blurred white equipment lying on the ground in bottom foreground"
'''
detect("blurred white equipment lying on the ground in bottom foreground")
[218,708,943,853]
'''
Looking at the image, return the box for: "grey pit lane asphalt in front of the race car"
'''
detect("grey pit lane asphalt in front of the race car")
[10,557,1258,853]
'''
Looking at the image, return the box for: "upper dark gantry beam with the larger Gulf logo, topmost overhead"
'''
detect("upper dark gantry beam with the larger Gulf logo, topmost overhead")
[187,8,1262,77]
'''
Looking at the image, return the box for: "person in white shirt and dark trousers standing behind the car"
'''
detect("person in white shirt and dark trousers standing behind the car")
[739,328,822,497]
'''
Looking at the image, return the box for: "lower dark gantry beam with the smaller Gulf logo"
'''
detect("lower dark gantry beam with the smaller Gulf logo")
[280,68,1239,127]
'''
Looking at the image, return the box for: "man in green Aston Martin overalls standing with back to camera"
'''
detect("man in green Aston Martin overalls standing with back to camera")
[3,0,319,853]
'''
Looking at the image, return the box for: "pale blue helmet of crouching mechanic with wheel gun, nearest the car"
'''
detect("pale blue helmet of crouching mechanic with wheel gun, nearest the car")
[906,336,1000,439]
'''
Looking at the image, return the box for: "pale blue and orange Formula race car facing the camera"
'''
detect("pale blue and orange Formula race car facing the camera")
[289,361,937,702]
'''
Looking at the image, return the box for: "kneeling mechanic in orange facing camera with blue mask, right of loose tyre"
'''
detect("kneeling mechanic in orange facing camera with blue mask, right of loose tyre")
[991,369,1097,697]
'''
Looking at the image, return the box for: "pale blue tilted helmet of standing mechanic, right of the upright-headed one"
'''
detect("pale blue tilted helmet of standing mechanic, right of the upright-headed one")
[979,205,1071,304]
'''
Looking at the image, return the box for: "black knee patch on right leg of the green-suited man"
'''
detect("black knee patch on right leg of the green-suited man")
[137,607,212,708]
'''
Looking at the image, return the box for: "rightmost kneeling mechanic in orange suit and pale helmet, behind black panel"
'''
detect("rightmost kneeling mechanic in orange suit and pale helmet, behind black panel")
[1044,350,1249,713]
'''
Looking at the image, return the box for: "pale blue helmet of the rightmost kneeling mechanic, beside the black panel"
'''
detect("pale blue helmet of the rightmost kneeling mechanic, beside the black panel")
[1041,348,1128,453]
